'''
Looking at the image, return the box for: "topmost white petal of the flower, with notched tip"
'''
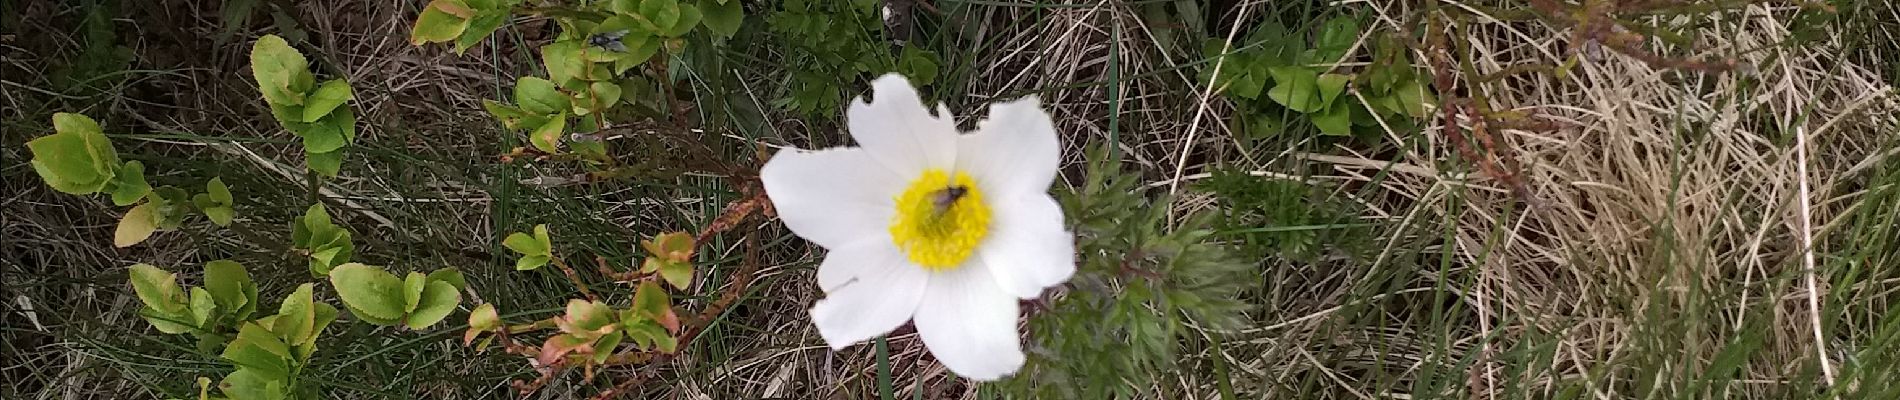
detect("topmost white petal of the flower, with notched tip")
[846,74,958,176]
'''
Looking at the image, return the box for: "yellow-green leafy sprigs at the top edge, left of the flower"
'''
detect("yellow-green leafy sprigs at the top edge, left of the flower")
[440,0,745,163]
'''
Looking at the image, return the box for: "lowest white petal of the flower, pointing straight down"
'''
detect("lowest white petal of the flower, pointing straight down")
[914,265,1022,381]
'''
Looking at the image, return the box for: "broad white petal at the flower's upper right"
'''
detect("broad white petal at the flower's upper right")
[958,97,1062,199]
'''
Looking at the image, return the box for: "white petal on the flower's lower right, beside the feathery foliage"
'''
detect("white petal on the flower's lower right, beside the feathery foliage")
[979,193,1075,300]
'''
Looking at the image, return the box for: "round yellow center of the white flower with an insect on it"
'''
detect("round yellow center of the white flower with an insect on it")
[891,169,990,271]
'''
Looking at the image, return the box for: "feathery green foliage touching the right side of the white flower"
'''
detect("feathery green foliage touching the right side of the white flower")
[1005,146,1248,398]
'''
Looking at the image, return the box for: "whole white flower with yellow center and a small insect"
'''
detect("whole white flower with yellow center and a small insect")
[760,74,1075,381]
